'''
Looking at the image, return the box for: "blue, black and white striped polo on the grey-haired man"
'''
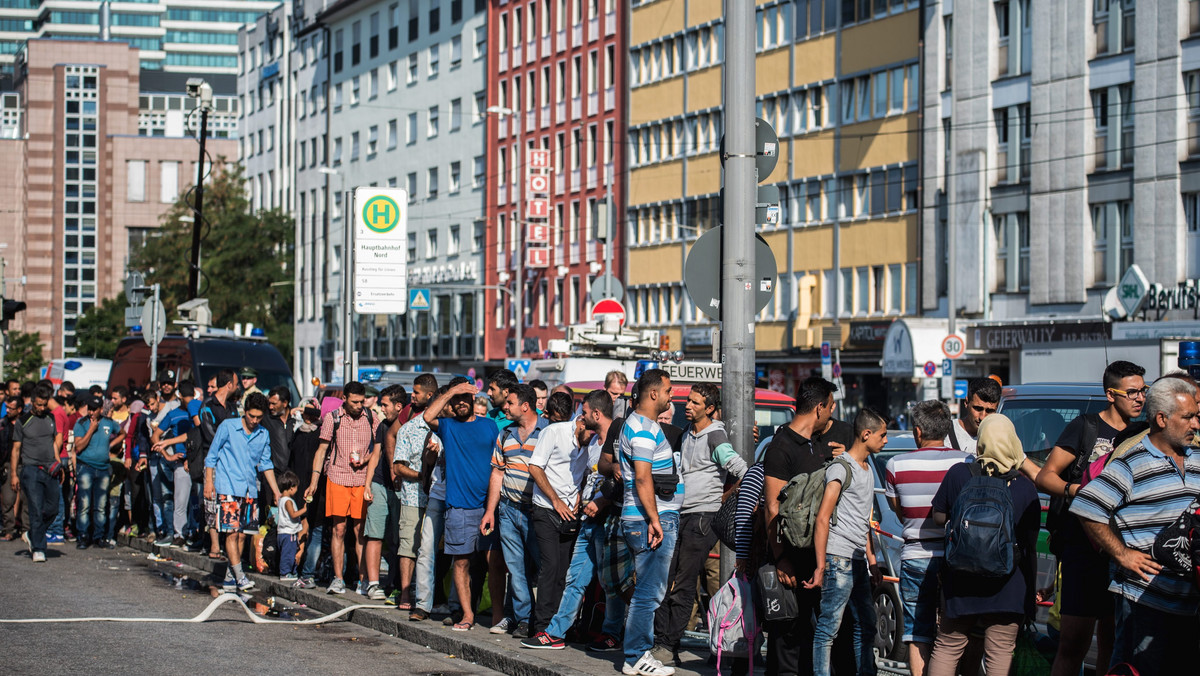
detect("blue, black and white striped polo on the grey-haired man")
[1070,437,1200,616]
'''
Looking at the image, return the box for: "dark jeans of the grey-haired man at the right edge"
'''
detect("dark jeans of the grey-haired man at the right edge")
[1112,594,1200,674]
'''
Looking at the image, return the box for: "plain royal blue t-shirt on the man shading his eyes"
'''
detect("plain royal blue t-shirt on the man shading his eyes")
[438,415,500,509]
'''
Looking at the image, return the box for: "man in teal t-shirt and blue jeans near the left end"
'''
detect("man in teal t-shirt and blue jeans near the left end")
[73,396,125,549]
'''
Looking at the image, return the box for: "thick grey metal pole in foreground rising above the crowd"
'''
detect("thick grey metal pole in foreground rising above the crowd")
[721,0,757,579]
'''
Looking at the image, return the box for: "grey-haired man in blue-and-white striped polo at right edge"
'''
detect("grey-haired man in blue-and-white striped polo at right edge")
[1070,378,1200,674]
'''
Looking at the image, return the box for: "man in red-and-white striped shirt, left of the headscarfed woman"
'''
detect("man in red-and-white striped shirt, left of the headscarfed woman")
[884,400,974,676]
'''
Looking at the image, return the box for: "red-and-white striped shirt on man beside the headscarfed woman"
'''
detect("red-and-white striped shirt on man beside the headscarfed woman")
[884,448,974,561]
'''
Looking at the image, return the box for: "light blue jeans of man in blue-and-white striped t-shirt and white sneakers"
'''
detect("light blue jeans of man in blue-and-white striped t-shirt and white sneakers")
[620,512,679,664]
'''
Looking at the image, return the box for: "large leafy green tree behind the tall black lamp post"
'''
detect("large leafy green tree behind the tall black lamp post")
[130,157,295,355]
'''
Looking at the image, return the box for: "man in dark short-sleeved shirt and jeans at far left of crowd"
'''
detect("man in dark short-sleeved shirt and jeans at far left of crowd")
[8,384,62,563]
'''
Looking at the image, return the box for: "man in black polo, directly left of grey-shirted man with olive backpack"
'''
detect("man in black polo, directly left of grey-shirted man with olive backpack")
[763,378,838,675]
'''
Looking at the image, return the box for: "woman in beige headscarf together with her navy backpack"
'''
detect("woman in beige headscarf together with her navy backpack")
[928,414,1042,676]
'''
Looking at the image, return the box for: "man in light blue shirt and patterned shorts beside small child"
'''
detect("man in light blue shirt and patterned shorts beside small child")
[204,393,280,592]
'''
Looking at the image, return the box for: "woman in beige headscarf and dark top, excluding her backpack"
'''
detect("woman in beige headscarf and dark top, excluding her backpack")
[928,414,1042,676]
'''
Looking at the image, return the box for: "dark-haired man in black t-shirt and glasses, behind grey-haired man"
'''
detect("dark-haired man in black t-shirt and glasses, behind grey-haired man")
[1037,361,1147,676]
